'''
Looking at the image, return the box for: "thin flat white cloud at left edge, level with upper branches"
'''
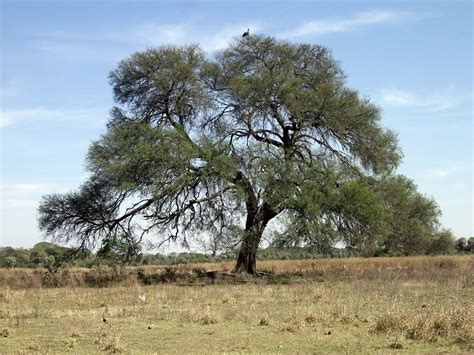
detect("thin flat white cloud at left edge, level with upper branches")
[0,107,107,128]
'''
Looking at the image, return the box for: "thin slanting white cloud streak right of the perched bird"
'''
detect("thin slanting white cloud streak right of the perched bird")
[279,10,422,38]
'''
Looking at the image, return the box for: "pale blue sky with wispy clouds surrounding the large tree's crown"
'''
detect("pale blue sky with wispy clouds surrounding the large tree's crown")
[0,0,474,247]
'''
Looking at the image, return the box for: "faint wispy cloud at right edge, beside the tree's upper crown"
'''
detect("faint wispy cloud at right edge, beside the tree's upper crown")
[381,87,473,112]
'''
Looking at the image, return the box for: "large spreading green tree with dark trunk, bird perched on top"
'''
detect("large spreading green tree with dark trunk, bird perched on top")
[39,35,401,274]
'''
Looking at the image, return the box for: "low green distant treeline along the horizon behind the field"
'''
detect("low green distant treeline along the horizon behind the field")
[0,238,474,268]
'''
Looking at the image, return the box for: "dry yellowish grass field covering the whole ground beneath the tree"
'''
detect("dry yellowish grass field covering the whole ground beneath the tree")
[0,256,474,354]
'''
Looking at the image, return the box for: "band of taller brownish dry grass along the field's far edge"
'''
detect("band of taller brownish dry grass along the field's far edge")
[0,255,474,289]
